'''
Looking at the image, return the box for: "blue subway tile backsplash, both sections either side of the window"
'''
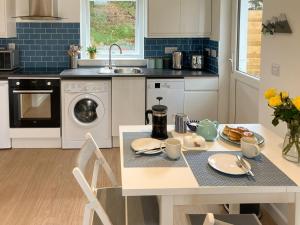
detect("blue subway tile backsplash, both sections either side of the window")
[0,22,219,73]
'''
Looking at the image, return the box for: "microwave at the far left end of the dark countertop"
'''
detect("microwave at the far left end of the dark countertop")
[0,50,19,70]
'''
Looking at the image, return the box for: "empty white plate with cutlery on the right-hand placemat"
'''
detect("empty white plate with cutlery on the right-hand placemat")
[208,153,251,175]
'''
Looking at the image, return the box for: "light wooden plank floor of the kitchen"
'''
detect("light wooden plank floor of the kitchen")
[0,149,274,225]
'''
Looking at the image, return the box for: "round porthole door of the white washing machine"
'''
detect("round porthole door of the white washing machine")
[70,95,105,127]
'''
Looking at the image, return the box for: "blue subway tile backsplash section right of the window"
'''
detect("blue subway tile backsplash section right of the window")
[144,38,219,73]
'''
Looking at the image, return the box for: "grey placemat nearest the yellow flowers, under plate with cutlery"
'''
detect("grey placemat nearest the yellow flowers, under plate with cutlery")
[184,151,297,186]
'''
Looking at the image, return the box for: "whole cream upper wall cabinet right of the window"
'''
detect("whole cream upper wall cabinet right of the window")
[147,0,212,37]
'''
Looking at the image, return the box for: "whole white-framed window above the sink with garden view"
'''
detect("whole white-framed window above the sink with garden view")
[81,0,144,59]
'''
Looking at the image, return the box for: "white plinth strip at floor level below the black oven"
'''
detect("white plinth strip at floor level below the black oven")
[12,138,61,149]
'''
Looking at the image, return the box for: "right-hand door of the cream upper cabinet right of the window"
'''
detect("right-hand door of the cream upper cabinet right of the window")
[180,0,212,36]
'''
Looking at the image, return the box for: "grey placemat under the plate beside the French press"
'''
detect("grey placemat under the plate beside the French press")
[123,132,187,167]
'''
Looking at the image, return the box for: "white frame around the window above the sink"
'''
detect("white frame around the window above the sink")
[80,0,145,59]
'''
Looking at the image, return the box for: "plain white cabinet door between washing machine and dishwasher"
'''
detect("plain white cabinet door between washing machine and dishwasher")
[112,77,146,137]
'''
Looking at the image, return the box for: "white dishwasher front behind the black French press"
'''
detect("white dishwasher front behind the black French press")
[147,79,184,124]
